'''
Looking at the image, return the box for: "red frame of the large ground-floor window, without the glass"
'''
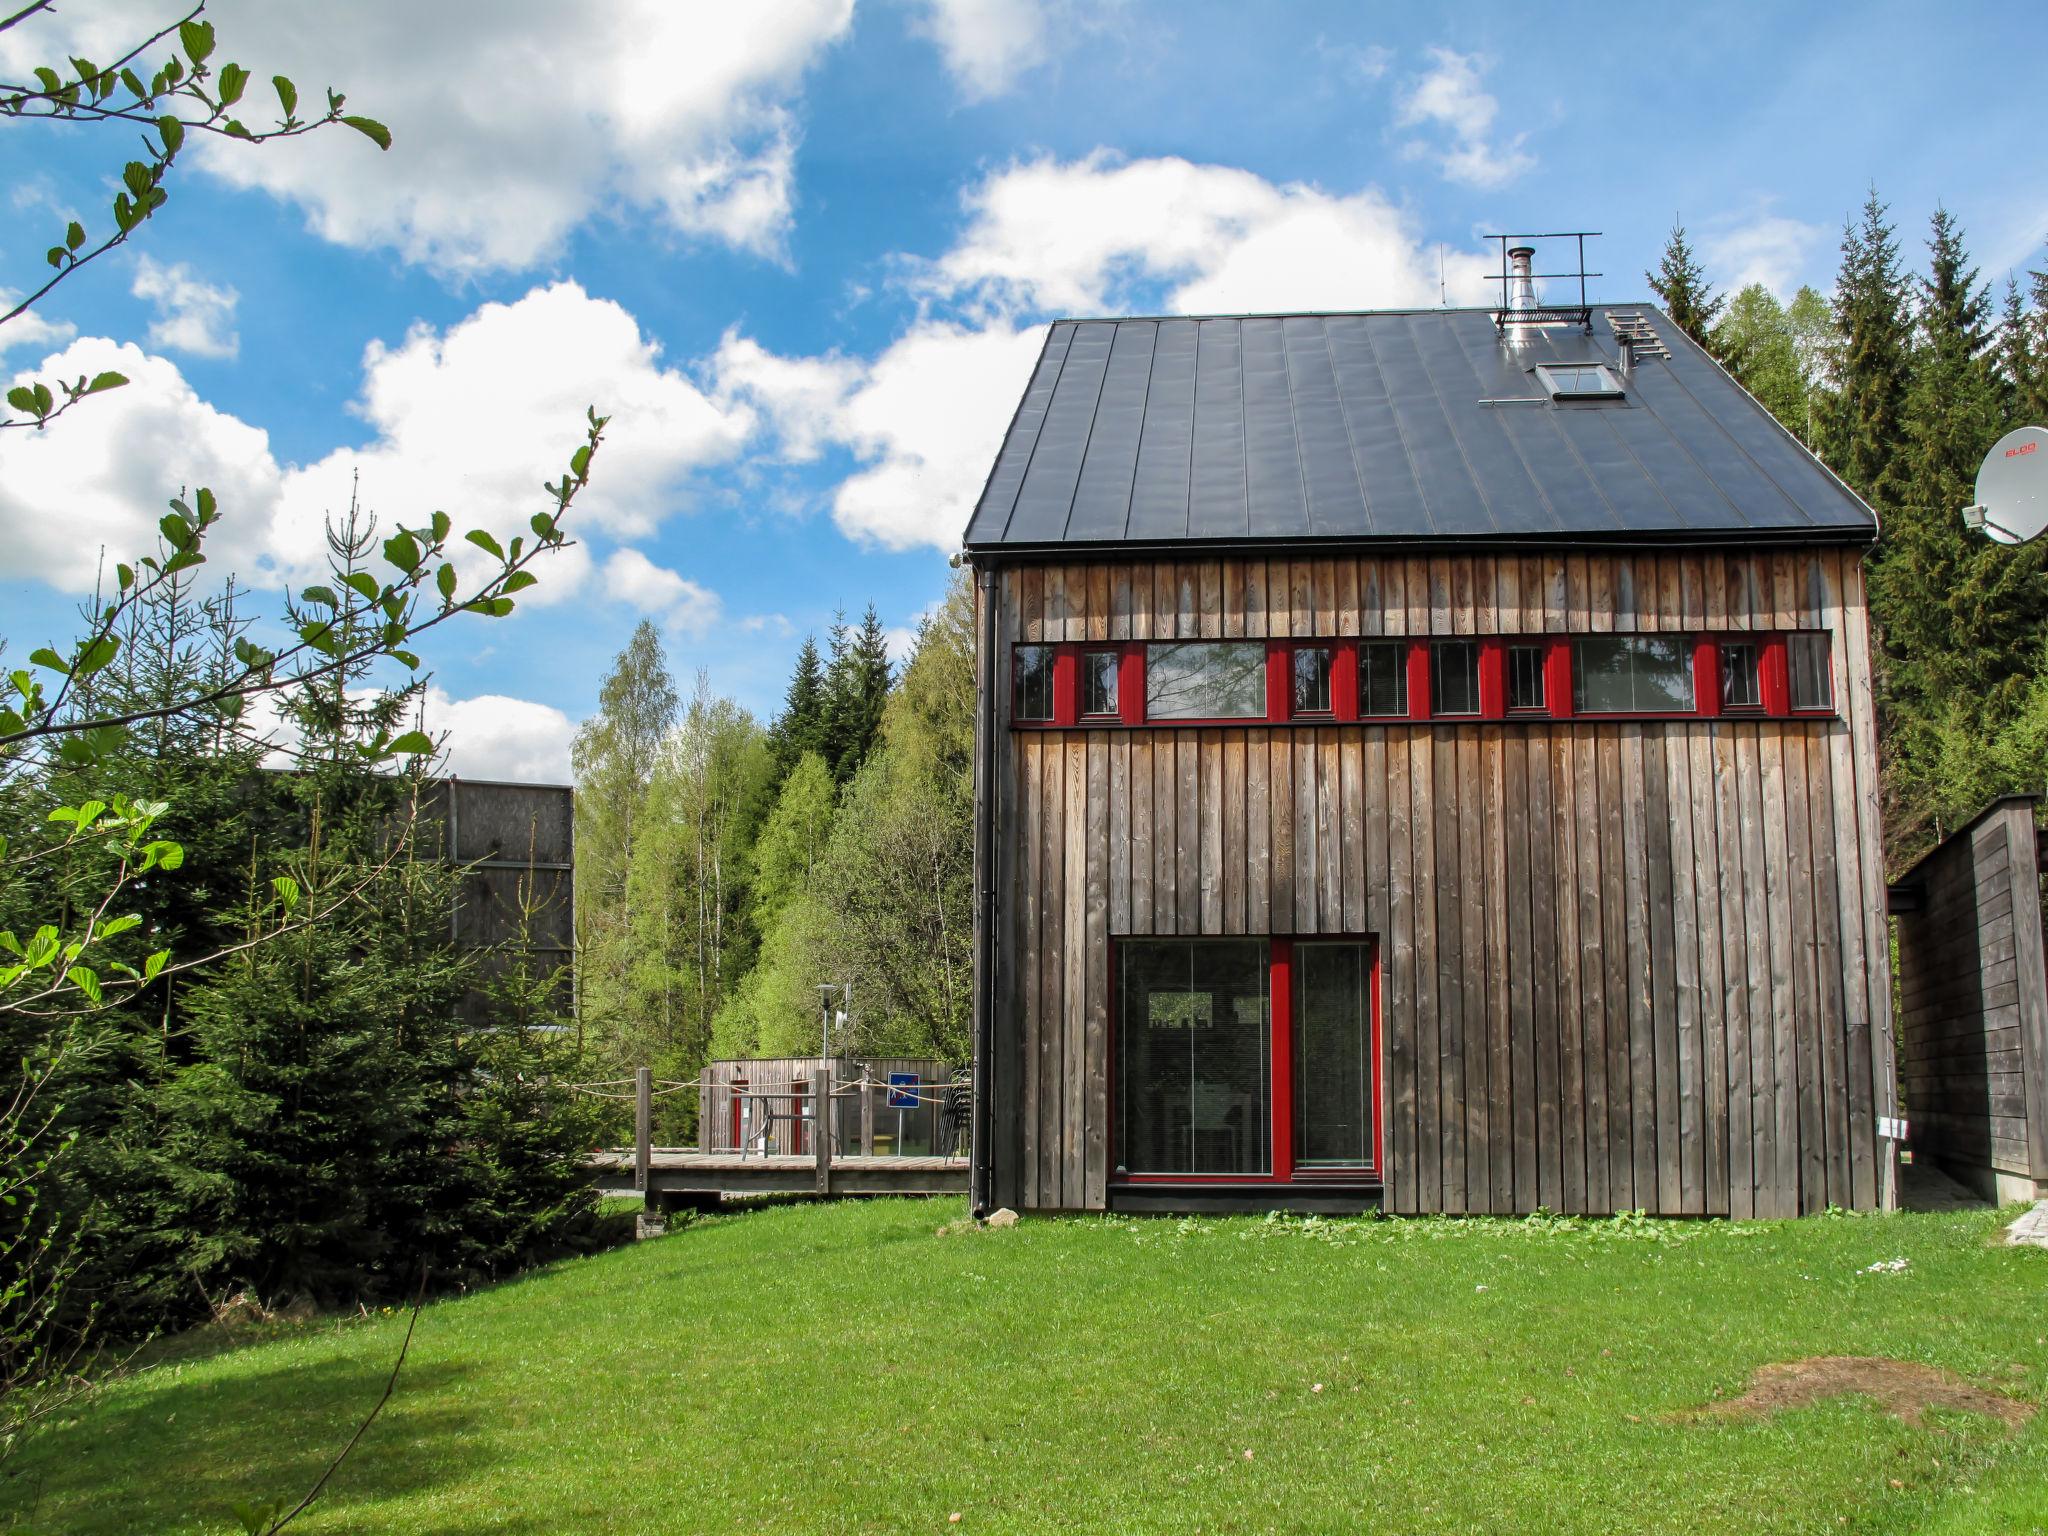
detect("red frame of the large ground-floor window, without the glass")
[1104,934,1386,1188]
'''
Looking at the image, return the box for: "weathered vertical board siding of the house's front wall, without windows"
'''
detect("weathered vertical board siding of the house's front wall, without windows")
[991,549,1892,1217]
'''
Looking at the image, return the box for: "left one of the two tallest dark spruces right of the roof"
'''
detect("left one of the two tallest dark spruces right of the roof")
[1819,188,1913,501]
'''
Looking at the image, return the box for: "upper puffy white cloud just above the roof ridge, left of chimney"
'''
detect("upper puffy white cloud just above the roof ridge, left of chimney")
[913,150,1485,313]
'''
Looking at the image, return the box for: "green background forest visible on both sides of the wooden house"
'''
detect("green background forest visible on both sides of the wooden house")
[575,193,2048,1141]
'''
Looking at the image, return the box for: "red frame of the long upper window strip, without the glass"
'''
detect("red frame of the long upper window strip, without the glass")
[1010,629,1841,731]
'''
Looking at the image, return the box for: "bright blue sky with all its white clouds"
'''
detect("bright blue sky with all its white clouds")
[0,0,2048,778]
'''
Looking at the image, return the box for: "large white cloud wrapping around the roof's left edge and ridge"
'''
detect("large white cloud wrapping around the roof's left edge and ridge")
[713,152,1487,551]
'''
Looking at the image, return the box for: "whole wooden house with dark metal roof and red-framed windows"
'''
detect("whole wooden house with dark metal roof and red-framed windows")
[965,290,1894,1217]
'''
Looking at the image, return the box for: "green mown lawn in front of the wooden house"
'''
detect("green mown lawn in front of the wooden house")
[8,1200,2048,1536]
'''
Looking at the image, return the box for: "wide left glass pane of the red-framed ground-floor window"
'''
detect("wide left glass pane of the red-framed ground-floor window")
[1116,938,1272,1176]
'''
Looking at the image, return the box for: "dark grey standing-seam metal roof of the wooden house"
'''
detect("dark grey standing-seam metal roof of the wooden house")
[965,305,1876,555]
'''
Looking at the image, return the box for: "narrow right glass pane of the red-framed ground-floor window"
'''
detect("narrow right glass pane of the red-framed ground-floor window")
[1292,940,1378,1169]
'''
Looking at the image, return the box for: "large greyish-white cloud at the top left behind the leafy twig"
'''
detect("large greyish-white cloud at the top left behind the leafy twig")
[0,0,852,272]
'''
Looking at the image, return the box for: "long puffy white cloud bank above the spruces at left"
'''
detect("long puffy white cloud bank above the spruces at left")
[0,283,754,604]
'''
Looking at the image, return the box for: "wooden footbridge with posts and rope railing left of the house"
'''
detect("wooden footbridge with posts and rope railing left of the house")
[588,1065,967,1210]
